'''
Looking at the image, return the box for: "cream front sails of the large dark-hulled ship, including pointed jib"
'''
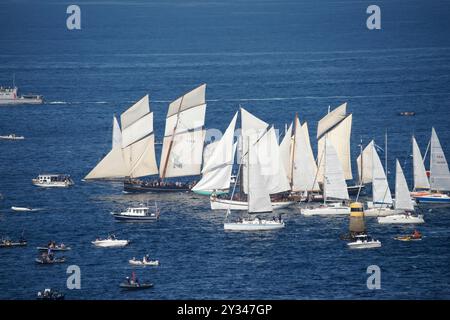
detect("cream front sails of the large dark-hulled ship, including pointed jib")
[85,95,158,180]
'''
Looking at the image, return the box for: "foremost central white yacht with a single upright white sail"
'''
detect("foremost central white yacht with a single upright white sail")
[223,139,285,231]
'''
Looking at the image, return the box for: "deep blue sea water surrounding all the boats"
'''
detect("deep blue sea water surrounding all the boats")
[0,0,450,299]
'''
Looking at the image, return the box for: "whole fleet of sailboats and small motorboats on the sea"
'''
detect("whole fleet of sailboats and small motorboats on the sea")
[0,84,450,298]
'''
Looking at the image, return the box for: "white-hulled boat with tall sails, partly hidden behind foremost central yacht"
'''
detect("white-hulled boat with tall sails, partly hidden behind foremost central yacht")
[210,108,294,210]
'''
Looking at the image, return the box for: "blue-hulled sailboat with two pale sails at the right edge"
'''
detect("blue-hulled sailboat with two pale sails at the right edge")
[412,128,450,203]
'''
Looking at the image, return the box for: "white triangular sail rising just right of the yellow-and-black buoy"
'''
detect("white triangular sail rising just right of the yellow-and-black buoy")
[372,143,392,205]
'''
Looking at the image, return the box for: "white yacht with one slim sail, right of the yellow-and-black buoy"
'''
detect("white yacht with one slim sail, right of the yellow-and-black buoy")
[378,160,425,224]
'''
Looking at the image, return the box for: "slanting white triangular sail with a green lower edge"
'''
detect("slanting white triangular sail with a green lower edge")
[192,112,238,191]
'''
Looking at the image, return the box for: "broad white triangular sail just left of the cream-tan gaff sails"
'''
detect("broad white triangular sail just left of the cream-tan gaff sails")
[292,118,320,192]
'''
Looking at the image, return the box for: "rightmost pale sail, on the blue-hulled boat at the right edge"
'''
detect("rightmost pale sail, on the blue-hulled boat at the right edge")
[430,128,450,191]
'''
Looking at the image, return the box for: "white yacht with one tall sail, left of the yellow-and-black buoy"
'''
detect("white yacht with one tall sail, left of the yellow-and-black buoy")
[300,139,350,216]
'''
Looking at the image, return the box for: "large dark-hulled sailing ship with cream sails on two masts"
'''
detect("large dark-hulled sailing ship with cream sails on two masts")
[85,84,206,192]
